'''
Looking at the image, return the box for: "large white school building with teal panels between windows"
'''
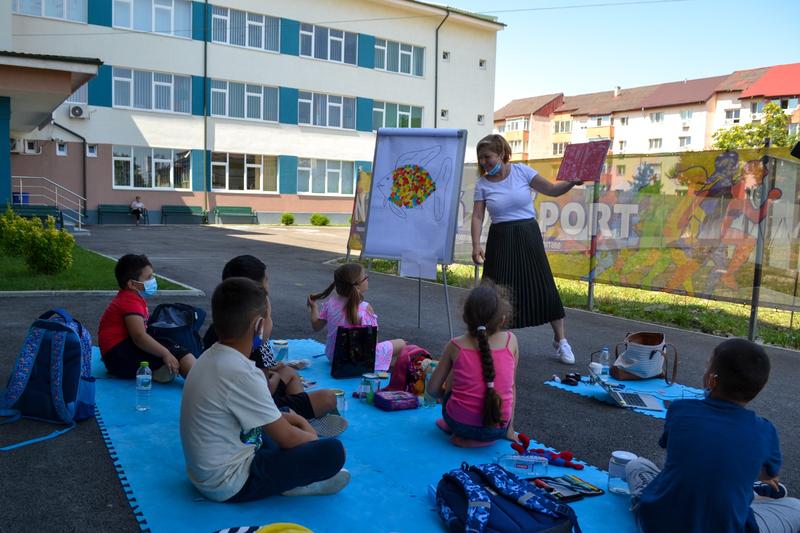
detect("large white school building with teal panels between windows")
[6,0,504,223]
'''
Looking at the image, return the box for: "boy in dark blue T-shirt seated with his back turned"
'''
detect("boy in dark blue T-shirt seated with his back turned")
[626,339,800,533]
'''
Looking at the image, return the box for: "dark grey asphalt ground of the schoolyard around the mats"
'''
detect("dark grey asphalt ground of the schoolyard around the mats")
[0,222,800,533]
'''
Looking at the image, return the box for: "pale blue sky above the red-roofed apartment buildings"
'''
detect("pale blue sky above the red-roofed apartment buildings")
[446,0,800,109]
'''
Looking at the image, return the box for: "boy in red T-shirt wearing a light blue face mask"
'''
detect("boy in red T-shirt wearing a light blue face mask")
[97,254,195,383]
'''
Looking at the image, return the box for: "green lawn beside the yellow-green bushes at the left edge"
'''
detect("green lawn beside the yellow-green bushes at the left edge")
[0,245,186,291]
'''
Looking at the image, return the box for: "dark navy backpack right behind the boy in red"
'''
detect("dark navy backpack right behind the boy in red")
[147,303,206,357]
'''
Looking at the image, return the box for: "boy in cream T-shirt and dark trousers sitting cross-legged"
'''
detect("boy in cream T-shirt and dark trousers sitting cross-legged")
[180,278,350,502]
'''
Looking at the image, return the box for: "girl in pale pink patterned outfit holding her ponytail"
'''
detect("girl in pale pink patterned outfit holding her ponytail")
[306,263,406,371]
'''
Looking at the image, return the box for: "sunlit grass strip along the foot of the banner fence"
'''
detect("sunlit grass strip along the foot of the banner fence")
[362,259,800,349]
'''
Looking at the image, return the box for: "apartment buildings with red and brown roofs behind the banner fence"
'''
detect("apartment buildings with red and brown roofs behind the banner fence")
[495,63,800,160]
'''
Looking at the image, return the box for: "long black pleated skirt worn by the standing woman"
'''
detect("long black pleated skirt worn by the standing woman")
[483,218,565,328]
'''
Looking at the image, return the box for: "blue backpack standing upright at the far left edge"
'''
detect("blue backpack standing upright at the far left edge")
[0,309,95,452]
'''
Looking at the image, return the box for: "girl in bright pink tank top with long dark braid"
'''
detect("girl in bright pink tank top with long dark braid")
[428,281,519,447]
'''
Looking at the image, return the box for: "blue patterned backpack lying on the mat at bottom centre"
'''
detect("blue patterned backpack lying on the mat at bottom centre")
[436,463,581,533]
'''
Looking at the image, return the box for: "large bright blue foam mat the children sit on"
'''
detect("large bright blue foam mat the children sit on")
[93,340,636,533]
